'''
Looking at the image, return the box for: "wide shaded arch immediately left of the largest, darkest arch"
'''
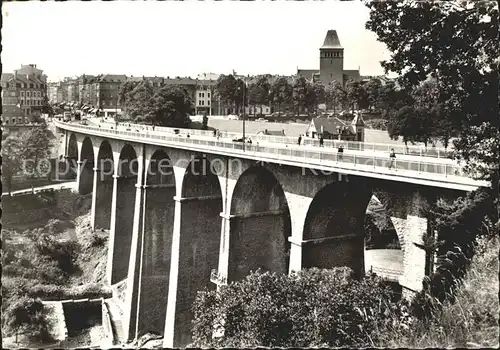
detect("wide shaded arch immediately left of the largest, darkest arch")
[228,166,291,281]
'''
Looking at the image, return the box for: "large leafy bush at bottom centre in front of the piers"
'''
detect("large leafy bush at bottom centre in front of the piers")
[193,268,402,347]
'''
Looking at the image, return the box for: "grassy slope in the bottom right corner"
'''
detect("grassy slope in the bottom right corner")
[380,237,500,349]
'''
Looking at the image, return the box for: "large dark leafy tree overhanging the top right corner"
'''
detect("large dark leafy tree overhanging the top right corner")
[366,0,500,182]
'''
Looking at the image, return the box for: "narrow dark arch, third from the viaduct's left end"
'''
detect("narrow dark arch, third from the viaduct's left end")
[94,141,115,230]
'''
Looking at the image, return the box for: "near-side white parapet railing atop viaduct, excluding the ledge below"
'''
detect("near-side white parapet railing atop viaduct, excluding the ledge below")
[57,122,467,177]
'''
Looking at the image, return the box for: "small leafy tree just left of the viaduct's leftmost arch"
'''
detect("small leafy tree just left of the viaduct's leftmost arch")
[22,123,52,188]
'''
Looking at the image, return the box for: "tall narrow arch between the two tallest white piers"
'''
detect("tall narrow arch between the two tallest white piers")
[138,149,176,336]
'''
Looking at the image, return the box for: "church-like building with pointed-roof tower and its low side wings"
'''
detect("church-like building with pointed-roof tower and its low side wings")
[297,30,361,86]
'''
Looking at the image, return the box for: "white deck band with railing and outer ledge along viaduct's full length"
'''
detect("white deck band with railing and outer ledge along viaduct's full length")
[55,121,487,188]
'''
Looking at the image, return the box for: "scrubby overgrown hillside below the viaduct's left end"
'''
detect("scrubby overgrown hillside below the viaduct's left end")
[2,191,110,341]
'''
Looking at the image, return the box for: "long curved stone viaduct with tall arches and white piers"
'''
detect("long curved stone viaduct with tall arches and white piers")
[56,122,486,347]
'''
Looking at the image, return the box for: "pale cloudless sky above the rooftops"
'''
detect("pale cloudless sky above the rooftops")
[1,0,389,81]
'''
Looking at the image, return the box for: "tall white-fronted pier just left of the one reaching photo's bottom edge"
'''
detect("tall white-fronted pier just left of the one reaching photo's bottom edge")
[124,184,175,339]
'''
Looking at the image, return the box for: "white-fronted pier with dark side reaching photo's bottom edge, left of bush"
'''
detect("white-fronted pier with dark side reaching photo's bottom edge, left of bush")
[163,195,222,348]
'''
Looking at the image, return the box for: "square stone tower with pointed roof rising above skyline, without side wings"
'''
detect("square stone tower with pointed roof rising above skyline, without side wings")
[319,29,344,86]
